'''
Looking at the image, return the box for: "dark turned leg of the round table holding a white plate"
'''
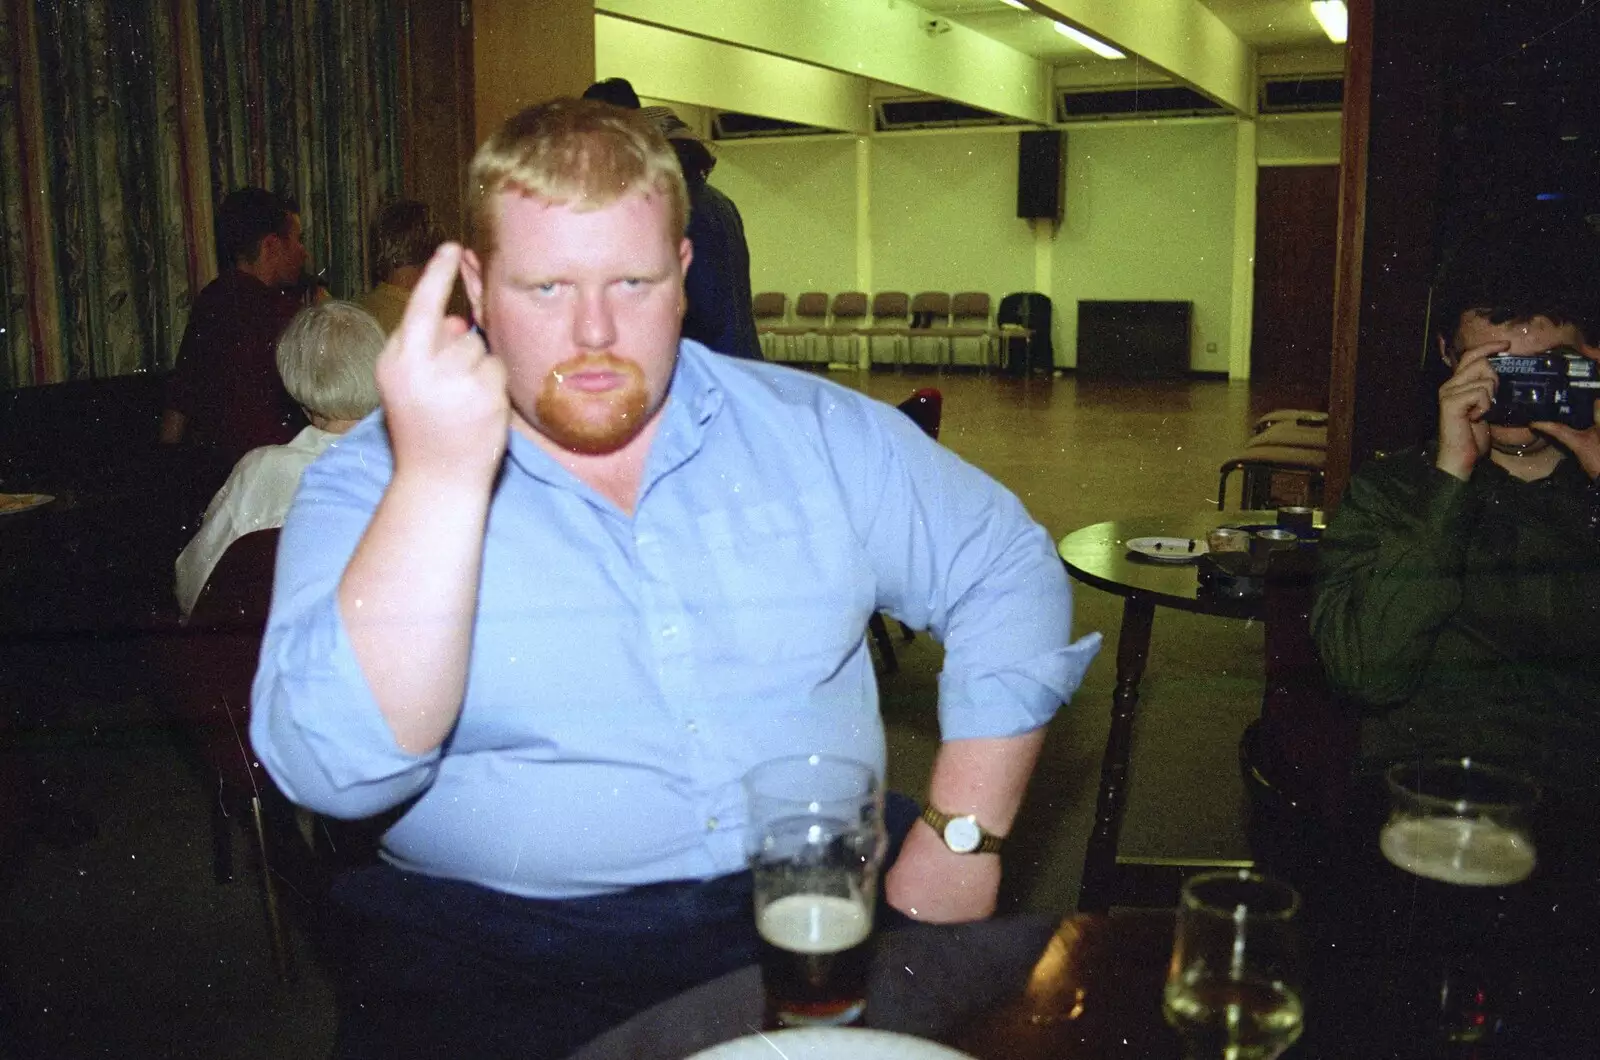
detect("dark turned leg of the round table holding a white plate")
[1078,596,1155,913]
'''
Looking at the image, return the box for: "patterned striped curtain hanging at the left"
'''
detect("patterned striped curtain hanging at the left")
[0,0,402,387]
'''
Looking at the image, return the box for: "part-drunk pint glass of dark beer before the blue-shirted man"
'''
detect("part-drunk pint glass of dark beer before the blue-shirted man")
[744,754,885,1026]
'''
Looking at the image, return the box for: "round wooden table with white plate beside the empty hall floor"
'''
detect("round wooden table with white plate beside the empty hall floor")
[1056,511,1277,913]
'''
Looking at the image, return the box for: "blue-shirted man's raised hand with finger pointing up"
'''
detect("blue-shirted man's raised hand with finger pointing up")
[378,243,510,485]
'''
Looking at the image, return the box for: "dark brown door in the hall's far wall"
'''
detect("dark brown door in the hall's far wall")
[1250,165,1339,408]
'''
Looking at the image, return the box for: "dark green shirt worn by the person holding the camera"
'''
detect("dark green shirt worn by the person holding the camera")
[1312,447,1600,793]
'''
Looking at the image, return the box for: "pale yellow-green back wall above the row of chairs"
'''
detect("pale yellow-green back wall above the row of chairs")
[712,115,1338,371]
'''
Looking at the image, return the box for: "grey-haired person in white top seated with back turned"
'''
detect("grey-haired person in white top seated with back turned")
[176,301,386,620]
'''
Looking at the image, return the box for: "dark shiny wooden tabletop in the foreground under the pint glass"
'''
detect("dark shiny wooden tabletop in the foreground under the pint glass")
[571,909,1182,1060]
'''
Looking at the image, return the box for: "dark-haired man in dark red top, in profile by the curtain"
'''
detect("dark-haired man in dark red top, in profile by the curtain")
[160,187,306,473]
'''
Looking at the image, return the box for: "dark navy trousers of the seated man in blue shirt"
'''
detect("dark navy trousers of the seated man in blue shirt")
[333,794,918,1060]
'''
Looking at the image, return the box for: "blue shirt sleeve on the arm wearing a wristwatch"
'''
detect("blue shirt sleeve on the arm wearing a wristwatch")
[821,389,1101,740]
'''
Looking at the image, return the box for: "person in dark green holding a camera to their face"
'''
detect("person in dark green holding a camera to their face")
[1312,229,1600,805]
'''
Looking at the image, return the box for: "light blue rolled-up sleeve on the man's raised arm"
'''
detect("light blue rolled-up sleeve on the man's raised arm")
[250,420,440,818]
